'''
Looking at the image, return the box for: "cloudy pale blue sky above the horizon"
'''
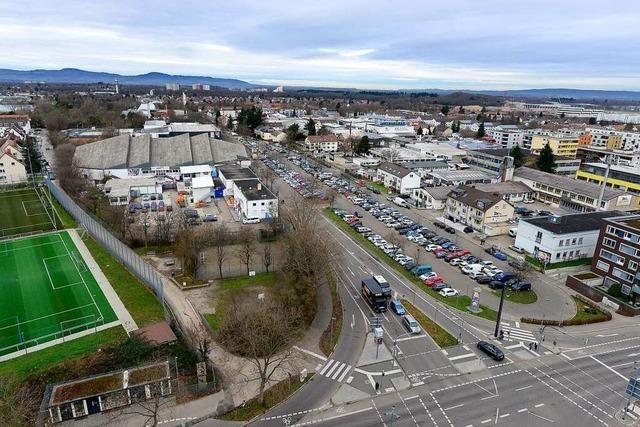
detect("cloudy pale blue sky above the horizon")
[5,0,640,90]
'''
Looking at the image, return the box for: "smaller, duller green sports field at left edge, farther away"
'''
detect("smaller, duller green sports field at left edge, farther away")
[0,188,54,238]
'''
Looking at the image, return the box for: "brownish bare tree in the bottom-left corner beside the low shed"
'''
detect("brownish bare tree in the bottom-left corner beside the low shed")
[0,374,39,426]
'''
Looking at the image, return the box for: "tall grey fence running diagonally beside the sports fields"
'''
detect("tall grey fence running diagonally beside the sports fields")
[44,179,170,321]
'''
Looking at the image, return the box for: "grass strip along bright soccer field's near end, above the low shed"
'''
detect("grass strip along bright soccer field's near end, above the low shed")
[0,327,127,380]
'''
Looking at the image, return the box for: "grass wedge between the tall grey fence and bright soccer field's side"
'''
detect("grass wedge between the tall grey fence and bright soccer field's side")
[84,234,164,327]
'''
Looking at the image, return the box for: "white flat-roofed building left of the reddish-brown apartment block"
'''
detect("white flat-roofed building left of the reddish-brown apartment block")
[515,211,621,263]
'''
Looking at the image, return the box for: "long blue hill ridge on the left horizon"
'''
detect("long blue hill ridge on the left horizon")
[0,68,257,89]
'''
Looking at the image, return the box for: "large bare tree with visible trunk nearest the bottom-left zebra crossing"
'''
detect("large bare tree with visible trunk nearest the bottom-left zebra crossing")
[218,302,300,405]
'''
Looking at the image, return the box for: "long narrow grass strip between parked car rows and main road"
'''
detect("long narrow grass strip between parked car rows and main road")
[324,208,498,321]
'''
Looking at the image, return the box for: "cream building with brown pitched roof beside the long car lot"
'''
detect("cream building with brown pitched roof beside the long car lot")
[444,185,514,236]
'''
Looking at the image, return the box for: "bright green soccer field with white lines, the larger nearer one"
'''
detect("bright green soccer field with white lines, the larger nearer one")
[0,232,117,356]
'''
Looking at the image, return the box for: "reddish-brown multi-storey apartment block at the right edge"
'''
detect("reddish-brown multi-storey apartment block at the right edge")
[591,215,640,301]
